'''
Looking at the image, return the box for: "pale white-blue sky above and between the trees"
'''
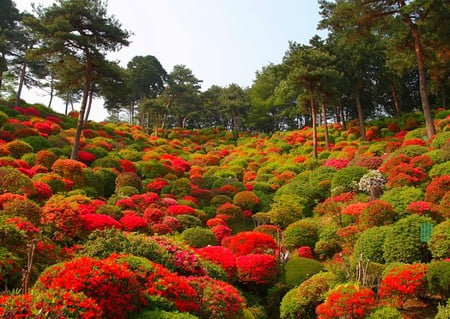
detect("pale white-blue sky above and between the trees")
[13,0,323,121]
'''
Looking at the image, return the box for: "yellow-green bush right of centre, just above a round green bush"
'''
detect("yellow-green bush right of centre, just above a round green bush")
[268,195,307,228]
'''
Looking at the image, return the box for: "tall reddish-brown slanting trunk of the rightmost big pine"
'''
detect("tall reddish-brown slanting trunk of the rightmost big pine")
[402,13,436,138]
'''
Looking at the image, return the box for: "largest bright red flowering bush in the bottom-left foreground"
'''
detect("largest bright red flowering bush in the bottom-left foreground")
[35,257,146,319]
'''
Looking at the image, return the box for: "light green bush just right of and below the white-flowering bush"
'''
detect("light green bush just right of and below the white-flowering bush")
[380,186,424,217]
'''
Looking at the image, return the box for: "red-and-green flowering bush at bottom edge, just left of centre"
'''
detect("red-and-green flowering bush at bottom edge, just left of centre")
[187,276,245,319]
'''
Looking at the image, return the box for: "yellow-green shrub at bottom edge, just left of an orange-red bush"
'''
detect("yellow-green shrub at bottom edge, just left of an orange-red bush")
[280,272,336,319]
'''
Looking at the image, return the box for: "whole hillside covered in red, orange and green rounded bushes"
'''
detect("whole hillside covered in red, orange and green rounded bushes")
[0,104,450,319]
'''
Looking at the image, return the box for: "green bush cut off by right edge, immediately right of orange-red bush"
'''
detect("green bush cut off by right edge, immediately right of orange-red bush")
[425,260,450,299]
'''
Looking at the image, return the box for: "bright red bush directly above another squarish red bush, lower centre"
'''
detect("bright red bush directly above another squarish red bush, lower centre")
[223,231,277,256]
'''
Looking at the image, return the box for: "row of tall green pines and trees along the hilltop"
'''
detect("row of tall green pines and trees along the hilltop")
[0,0,450,156]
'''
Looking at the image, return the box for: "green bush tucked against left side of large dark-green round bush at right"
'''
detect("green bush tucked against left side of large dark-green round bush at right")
[353,226,391,264]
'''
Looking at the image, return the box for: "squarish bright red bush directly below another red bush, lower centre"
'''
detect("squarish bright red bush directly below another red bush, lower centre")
[236,254,279,284]
